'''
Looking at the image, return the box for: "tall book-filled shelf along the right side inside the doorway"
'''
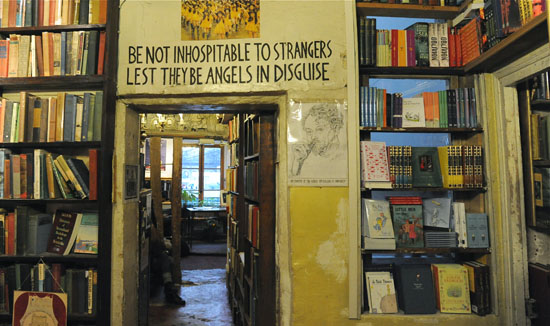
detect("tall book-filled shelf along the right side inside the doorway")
[226,113,275,325]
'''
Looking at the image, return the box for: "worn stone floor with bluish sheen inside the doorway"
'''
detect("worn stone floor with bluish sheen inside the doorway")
[149,243,233,326]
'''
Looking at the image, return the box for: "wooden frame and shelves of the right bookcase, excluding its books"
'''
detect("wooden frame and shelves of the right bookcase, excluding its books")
[356,1,498,324]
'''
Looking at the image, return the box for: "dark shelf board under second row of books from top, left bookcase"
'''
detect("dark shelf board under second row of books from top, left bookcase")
[0,75,104,92]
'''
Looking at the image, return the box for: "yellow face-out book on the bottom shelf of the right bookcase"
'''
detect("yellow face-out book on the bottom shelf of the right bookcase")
[433,264,472,314]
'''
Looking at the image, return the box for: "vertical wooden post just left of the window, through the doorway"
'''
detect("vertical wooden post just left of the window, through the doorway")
[172,137,182,283]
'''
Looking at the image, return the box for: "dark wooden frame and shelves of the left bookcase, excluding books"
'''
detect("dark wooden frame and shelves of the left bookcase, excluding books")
[0,1,119,325]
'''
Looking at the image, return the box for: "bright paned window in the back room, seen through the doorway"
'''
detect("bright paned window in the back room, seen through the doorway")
[181,145,223,206]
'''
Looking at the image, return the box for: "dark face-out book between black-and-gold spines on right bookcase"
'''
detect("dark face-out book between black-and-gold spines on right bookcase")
[412,147,443,187]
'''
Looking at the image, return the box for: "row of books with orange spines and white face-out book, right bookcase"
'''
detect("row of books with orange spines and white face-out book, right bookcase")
[359,86,478,128]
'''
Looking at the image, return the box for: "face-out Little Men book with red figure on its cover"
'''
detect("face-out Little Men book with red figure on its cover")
[391,205,424,248]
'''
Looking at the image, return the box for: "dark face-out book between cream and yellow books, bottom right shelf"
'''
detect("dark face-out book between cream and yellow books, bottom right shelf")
[396,264,436,314]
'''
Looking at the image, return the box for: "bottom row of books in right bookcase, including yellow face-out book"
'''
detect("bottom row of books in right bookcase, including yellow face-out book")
[364,261,491,316]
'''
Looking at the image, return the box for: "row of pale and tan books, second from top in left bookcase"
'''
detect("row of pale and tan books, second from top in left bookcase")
[0,31,105,77]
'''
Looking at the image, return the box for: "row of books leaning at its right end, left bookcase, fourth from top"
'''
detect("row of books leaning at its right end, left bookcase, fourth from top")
[0,149,98,200]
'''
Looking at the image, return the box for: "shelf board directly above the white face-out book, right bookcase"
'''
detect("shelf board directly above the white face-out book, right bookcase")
[359,65,464,78]
